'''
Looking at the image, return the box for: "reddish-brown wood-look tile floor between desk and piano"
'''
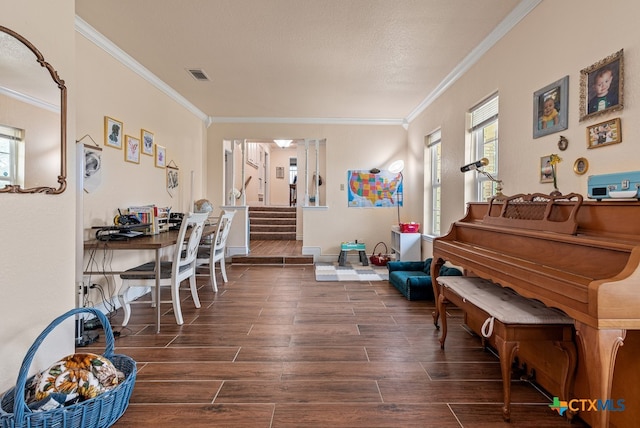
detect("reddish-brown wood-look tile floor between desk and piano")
[82,265,585,428]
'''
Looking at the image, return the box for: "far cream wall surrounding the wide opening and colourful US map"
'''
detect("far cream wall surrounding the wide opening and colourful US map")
[207,123,410,257]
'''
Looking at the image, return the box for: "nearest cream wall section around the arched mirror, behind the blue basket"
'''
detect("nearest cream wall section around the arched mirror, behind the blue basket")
[0,0,76,391]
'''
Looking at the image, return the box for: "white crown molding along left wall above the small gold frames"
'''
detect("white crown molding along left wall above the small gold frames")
[75,15,209,123]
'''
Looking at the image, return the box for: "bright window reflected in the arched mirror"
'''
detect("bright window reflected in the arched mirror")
[0,125,24,187]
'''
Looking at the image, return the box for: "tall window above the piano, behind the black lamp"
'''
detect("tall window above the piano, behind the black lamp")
[470,95,498,201]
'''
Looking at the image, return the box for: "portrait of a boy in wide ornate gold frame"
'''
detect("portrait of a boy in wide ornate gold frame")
[580,49,624,121]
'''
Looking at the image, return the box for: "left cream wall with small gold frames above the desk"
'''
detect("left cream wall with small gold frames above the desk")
[75,29,209,298]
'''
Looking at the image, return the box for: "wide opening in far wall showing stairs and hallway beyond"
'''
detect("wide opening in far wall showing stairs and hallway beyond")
[223,139,326,257]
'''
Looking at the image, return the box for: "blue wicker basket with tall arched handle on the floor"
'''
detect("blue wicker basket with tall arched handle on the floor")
[0,308,137,428]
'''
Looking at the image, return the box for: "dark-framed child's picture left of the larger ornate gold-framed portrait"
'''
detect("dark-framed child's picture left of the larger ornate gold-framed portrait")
[533,76,569,138]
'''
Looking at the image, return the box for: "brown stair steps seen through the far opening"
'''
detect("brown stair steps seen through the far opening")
[249,206,296,241]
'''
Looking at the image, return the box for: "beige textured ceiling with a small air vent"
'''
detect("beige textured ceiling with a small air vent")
[76,0,518,120]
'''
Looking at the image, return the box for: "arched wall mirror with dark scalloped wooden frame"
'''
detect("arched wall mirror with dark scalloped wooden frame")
[0,26,67,194]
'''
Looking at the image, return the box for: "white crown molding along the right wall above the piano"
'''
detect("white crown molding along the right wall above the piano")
[406,0,542,122]
